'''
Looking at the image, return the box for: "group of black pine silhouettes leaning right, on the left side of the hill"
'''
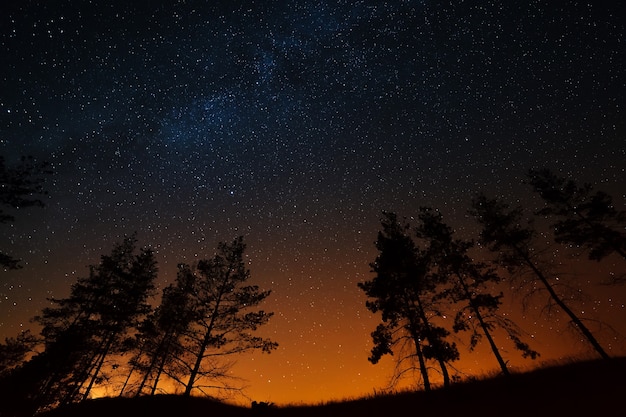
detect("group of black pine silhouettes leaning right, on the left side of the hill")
[0,236,277,416]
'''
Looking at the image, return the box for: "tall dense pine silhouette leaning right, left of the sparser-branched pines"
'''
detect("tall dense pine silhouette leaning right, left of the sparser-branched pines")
[28,236,157,406]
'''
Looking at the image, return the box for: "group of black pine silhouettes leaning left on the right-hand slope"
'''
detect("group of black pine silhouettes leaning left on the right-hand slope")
[358,169,626,390]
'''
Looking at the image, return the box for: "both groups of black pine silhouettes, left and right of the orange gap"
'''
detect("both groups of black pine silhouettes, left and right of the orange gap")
[0,170,626,416]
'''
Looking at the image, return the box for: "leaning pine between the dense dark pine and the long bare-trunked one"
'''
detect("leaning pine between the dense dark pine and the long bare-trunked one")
[416,207,538,375]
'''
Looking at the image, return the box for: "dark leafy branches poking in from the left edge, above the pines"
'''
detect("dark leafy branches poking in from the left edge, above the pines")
[0,156,52,270]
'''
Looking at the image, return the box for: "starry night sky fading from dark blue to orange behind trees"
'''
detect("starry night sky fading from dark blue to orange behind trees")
[0,0,626,403]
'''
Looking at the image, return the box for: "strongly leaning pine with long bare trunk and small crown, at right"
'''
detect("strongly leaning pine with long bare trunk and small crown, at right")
[470,194,609,359]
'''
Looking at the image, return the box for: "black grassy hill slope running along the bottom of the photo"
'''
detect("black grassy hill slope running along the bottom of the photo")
[44,358,626,417]
